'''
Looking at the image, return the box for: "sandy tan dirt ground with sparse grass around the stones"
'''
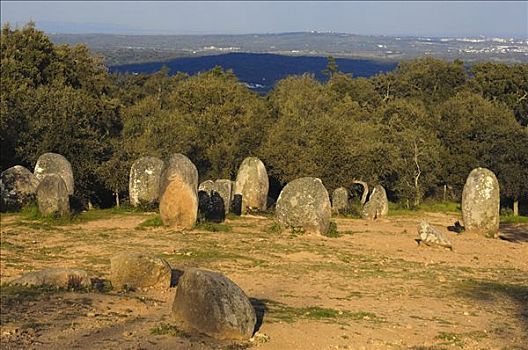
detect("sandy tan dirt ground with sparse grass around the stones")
[0,213,528,349]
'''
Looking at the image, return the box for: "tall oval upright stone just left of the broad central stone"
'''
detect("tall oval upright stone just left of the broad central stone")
[235,157,269,214]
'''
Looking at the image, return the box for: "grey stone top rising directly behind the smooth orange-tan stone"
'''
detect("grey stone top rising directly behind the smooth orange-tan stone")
[160,153,198,195]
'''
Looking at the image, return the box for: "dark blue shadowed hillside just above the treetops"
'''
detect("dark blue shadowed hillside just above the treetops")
[110,53,397,93]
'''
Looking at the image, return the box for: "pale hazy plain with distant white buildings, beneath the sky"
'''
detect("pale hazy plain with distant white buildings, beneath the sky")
[50,32,528,66]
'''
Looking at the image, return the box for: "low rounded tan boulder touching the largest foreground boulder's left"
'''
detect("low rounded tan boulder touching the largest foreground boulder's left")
[110,253,172,289]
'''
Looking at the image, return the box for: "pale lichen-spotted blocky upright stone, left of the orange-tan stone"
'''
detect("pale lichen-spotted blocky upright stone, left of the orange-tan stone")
[128,157,164,207]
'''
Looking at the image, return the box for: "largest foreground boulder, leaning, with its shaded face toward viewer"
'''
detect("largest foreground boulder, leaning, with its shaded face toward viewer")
[172,269,257,340]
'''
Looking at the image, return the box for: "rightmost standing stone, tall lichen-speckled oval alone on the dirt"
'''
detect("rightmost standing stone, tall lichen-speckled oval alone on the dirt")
[462,168,500,234]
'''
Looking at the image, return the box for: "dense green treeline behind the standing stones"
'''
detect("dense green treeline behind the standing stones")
[0,24,528,212]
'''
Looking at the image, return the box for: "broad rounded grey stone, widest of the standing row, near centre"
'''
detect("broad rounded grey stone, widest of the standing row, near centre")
[275,177,332,234]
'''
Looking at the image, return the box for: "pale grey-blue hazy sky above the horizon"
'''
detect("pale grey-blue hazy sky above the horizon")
[1,0,528,38]
